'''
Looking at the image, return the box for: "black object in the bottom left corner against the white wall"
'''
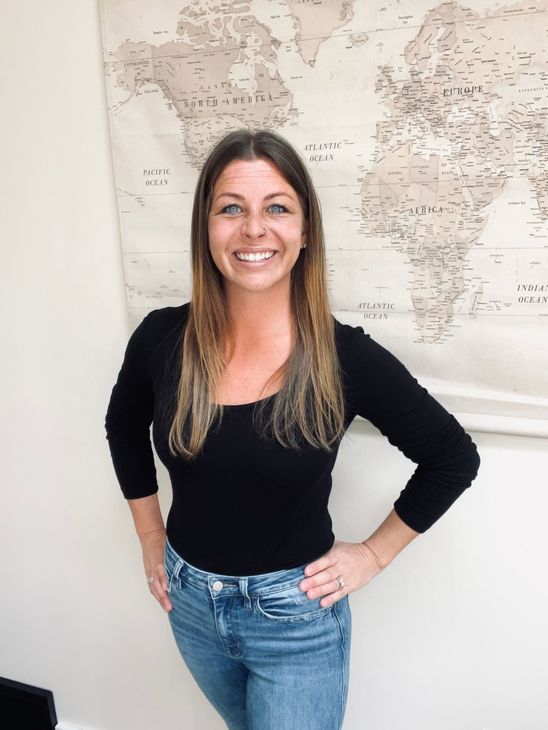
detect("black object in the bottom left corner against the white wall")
[0,677,57,730]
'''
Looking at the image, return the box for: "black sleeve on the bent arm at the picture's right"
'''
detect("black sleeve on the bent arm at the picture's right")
[344,327,480,532]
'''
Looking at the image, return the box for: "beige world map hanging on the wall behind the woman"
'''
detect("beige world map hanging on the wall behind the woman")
[101,0,548,436]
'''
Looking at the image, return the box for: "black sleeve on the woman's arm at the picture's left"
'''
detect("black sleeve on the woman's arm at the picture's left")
[105,312,158,499]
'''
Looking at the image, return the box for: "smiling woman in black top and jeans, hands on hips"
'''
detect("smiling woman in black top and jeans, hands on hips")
[106,130,479,730]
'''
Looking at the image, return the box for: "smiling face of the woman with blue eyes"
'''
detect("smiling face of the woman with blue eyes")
[208,160,305,295]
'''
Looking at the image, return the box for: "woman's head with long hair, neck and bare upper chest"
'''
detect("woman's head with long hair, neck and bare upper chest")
[174,130,344,456]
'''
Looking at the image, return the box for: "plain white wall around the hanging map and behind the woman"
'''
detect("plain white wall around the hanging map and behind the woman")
[0,0,548,730]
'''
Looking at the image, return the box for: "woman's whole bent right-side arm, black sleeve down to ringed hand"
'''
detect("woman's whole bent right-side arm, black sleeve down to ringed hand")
[300,325,479,606]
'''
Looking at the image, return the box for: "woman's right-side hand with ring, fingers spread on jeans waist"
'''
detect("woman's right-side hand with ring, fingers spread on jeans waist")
[299,541,383,608]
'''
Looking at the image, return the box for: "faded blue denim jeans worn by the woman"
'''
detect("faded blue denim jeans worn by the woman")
[165,542,351,730]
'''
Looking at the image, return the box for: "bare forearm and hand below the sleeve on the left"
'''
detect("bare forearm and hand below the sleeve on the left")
[127,494,172,611]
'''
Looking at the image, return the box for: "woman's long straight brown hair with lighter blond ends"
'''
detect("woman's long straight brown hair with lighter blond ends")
[169,129,344,459]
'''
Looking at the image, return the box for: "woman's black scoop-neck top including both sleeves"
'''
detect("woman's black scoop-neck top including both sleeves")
[105,304,479,575]
